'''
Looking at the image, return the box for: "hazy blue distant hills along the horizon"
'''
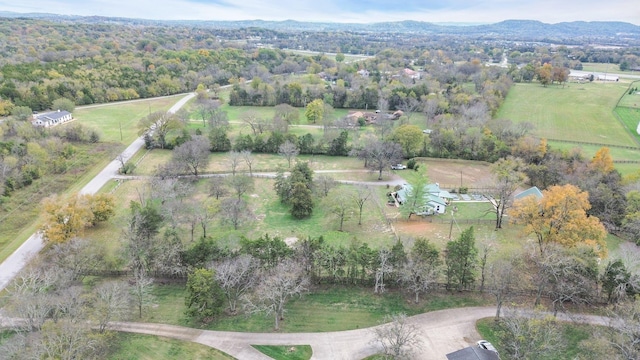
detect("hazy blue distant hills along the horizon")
[0,11,640,45]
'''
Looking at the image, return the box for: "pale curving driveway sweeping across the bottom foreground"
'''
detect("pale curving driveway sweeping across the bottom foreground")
[113,307,496,360]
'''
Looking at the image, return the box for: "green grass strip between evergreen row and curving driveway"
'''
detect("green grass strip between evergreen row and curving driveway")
[142,285,492,332]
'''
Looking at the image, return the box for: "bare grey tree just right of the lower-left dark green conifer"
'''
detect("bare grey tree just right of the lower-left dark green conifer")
[213,254,260,314]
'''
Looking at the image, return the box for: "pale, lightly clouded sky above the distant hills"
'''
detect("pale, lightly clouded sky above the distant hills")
[0,0,640,25]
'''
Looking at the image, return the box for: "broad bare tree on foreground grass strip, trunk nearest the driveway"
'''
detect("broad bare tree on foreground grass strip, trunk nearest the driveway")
[247,259,309,330]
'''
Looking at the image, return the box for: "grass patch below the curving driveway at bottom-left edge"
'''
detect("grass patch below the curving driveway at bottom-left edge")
[107,333,234,360]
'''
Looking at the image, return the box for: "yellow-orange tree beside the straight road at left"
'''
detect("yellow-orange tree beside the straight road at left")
[42,195,93,243]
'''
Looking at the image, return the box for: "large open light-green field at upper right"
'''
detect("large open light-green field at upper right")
[496,83,637,146]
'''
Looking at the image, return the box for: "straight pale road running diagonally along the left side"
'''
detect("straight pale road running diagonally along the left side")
[0,93,195,290]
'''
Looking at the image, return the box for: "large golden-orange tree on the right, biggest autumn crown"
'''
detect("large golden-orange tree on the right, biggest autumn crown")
[509,184,607,256]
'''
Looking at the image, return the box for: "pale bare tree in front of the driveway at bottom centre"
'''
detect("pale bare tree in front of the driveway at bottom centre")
[373,314,422,359]
